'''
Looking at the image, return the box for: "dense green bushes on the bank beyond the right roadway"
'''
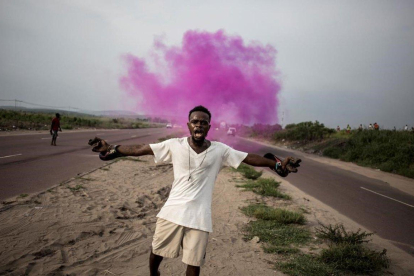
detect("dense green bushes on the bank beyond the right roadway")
[242,121,414,178]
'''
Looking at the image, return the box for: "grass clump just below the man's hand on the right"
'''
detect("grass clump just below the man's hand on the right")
[236,178,291,199]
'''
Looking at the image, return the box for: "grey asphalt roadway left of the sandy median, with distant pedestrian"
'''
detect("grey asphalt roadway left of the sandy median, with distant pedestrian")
[0,128,174,200]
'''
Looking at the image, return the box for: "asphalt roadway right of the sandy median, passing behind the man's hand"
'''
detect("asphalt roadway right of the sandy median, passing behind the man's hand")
[218,137,414,256]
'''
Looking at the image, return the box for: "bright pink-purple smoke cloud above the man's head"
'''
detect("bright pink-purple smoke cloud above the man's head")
[120,30,281,124]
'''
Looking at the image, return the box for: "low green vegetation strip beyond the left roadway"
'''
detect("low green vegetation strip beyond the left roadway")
[0,109,164,131]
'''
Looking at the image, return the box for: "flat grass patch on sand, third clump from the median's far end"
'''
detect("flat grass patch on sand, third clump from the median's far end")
[241,204,306,224]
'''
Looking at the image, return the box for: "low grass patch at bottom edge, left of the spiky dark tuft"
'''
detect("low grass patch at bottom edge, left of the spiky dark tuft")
[276,255,340,276]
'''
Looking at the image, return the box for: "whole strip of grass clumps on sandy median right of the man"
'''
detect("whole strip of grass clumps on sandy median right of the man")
[234,165,389,276]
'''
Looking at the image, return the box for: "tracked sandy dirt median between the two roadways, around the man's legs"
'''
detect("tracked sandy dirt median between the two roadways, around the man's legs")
[0,154,414,276]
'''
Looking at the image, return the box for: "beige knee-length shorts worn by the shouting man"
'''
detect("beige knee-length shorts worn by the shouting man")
[152,218,209,266]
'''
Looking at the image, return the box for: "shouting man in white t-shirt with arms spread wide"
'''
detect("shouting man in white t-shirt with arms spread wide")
[90,106,298,276]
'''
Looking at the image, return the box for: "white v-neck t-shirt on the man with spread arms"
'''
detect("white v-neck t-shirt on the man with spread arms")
[150,137,247,232]
